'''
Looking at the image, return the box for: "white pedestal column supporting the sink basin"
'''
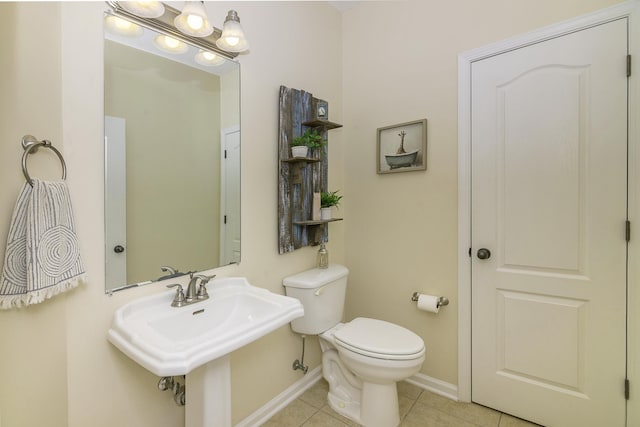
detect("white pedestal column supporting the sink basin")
[185,354,231,427]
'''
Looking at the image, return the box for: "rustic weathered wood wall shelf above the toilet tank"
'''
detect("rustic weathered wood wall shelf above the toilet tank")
[278,86,342,254]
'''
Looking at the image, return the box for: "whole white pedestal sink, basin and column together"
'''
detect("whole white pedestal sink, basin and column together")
[107,277,304,427]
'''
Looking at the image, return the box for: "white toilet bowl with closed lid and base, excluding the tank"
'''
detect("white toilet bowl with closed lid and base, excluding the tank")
[319,318,425,427]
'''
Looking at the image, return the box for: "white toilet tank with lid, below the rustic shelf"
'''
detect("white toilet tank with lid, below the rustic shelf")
[282,264,349,335]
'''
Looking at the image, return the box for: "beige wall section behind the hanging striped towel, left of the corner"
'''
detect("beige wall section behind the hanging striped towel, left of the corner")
[0,3,68,426]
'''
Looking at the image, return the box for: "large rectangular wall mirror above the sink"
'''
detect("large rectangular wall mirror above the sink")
[104,10,240,293]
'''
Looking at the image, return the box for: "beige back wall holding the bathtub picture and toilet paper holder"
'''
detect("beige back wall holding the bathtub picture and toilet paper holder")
[342,0,618,384]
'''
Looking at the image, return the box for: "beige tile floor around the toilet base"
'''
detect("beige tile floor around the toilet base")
[263,379,537,427]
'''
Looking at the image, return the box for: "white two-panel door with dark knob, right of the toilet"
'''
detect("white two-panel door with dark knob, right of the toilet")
[470,19,627,427]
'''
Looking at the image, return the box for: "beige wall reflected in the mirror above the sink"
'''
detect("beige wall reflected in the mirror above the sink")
[105,41,220,283]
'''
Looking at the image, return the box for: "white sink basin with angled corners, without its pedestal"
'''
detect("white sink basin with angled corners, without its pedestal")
[108,277,304,377]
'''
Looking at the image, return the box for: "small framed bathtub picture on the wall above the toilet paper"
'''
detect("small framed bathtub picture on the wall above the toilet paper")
[376,119,427,174]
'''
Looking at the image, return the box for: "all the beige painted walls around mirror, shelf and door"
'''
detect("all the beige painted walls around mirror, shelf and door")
[0,0,628,427]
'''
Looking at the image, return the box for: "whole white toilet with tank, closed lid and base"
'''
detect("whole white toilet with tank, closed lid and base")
[283,264,425,427]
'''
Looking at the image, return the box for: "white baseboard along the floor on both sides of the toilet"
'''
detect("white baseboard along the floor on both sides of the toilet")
[235,366,458,427]
